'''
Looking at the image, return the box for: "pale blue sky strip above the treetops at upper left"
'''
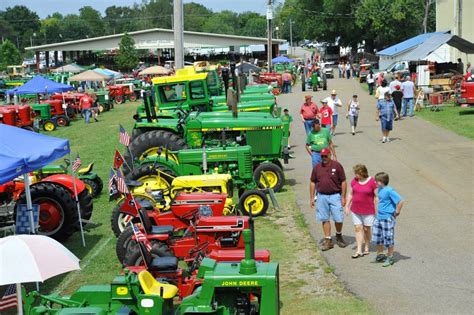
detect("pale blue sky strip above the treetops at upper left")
[0,0,267,18]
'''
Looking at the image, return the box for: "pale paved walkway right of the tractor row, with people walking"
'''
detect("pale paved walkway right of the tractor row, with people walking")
[278,75,474,314]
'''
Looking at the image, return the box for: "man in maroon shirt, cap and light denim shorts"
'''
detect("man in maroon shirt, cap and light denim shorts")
[309,148,347,251]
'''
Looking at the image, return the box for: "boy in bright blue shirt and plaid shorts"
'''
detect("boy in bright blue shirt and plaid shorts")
[372,172,403,267]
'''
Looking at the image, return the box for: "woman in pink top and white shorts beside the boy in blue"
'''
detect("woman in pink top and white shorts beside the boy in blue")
[345,164,377,258]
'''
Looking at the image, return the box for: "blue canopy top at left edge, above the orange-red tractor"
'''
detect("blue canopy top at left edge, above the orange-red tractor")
[0,124,70,184]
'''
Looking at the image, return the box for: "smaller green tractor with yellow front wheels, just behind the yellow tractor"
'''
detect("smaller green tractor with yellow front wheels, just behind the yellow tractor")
[127,145,270,216]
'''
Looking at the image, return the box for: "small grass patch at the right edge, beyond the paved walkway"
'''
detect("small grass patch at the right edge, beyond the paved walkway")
[416,105,474,139]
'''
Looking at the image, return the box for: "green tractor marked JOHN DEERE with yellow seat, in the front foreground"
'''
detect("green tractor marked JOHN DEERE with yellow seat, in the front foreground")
[22,230,280,315]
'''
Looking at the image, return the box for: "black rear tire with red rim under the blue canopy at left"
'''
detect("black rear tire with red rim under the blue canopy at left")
[17,182,78,242]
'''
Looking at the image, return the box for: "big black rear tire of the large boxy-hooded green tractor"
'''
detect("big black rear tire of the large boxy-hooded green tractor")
[123,130,188,173]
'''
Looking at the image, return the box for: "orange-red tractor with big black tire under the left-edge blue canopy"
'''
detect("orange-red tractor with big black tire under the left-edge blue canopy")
[0,174,93,241]
